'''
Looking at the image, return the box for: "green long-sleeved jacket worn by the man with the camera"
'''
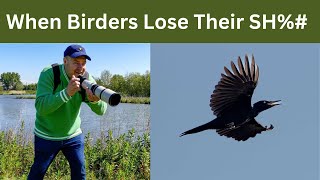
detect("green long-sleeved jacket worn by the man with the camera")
[34,64,107,140]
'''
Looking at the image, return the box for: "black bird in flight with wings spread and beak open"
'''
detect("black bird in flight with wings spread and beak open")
[180,55,281,141]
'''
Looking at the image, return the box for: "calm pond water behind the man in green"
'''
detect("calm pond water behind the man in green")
[0,95,150,137]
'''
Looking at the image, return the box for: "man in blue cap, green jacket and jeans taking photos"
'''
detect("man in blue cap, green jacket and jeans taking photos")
[28,45,107,180]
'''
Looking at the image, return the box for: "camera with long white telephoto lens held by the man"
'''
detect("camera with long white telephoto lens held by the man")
[78,76,121,106]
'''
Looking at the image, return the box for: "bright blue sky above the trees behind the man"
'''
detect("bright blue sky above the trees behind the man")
[0,43,150,84]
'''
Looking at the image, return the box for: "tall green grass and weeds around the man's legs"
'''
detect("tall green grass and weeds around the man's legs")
[0,123,150,180]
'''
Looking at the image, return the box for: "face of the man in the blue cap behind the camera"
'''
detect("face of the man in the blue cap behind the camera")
[63,56,86,79]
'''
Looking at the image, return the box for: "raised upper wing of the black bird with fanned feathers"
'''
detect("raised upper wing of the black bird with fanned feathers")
[210,55,259,117]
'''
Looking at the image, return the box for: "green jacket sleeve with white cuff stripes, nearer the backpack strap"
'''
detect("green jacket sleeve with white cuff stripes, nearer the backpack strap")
[35,67,71,115]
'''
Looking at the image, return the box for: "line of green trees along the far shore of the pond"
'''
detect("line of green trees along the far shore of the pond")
[0,70,150,97]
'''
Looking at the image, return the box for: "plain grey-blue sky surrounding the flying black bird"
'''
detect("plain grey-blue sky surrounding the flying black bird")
[151,43,319,180]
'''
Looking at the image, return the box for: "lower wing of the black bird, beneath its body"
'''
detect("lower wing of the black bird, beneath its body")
[216,119,273,141]
